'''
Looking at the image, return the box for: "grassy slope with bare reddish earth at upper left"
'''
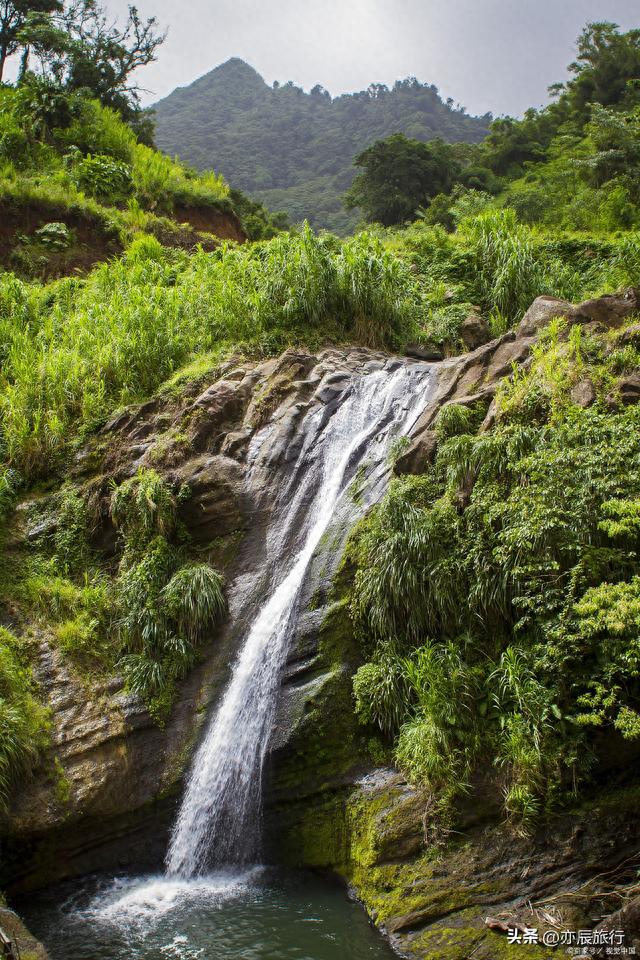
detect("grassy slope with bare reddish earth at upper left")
[0,77,245,279]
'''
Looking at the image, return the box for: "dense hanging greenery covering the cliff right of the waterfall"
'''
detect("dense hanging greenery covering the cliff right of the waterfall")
[351,320,640,825]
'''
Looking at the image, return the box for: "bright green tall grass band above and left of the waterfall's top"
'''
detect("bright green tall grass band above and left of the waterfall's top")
[0,228,418,477]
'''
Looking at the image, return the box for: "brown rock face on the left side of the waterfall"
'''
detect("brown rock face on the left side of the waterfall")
[2,349,432,890]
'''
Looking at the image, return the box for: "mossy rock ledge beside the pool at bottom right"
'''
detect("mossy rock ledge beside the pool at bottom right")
[339,771,640,960]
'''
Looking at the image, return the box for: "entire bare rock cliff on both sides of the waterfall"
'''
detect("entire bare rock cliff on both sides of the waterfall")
[1,292,640,958]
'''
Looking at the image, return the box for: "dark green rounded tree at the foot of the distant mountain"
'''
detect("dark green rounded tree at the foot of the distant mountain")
[344,133,460,226]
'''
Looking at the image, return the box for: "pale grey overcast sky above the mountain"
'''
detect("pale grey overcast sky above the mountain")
[8,0,640,115]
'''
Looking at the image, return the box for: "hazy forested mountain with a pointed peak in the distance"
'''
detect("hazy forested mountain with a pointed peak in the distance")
[155,57,490,232]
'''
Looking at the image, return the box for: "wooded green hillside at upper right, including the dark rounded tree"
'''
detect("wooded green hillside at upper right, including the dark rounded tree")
[345,23,640,232]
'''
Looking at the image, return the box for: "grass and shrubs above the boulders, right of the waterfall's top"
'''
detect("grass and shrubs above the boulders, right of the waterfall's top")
[379,209,640,353]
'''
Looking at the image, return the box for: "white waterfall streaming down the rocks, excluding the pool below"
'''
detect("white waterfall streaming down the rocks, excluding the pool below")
[166,364,431,878]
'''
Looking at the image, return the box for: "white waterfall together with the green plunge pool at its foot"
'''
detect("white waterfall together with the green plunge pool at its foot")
[25,356,432,960]
